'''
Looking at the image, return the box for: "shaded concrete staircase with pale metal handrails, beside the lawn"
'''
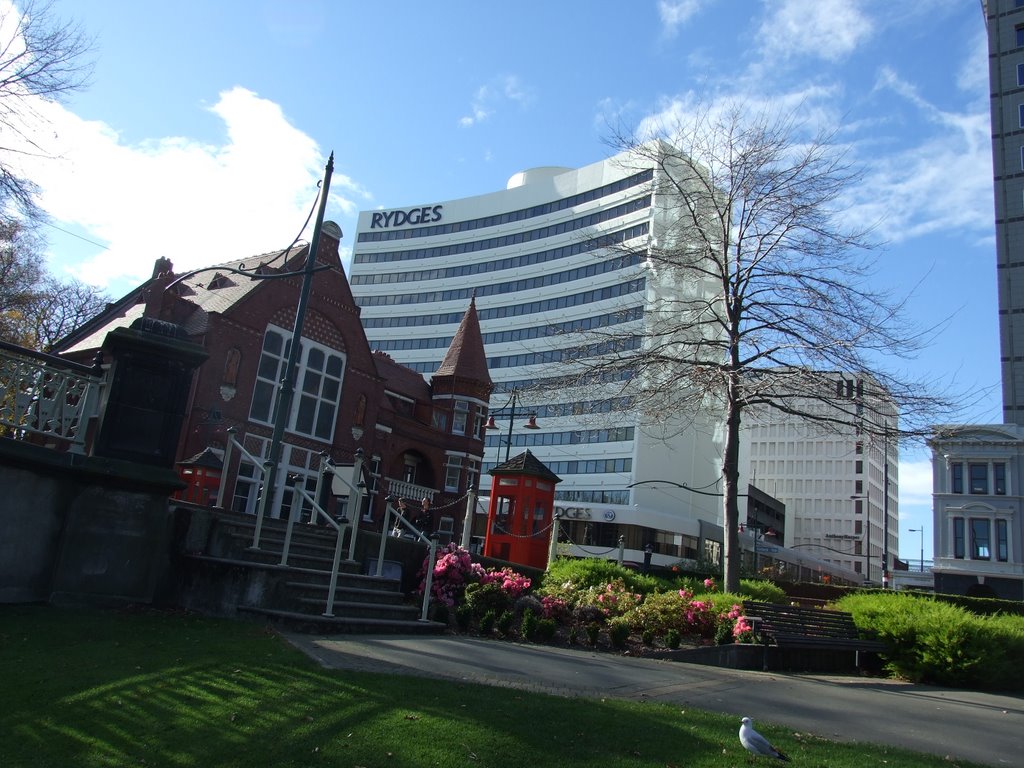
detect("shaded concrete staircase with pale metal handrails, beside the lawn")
[169,505,444,634]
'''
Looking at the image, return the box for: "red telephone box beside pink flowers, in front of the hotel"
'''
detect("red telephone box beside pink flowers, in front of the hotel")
[483,451,562,568]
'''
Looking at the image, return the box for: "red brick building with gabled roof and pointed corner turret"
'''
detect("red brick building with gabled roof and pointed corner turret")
[53,222,492,530]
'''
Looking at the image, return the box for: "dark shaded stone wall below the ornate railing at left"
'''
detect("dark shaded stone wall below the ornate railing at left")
[0,439,182,603]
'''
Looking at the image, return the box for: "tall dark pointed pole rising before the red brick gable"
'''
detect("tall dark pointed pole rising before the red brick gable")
[253,152,334,547]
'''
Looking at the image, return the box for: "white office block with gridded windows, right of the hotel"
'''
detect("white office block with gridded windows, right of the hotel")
[740,376,899,584]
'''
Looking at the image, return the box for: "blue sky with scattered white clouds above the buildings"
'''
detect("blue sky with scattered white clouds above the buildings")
[9,0,1000,558]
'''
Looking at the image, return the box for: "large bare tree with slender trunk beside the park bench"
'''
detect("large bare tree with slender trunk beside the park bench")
[574,104,949,591]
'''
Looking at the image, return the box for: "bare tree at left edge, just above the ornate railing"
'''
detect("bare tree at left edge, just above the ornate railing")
[0,215,108,350]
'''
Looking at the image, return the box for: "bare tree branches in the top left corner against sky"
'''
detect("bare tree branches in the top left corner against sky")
[0,0,92,217]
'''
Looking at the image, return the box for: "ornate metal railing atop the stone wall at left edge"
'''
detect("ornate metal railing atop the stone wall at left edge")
[0,342,103,454]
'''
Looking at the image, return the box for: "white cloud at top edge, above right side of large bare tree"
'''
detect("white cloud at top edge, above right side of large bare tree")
[758,0,873,61]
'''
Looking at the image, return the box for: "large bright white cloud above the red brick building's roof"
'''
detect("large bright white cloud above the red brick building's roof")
[14,87,367,287]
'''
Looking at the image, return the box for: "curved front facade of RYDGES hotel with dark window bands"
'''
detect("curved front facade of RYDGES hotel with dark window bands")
[350,148,720,524]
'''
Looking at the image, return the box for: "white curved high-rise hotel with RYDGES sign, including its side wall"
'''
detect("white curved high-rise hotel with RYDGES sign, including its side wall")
[350,145,721,560]
